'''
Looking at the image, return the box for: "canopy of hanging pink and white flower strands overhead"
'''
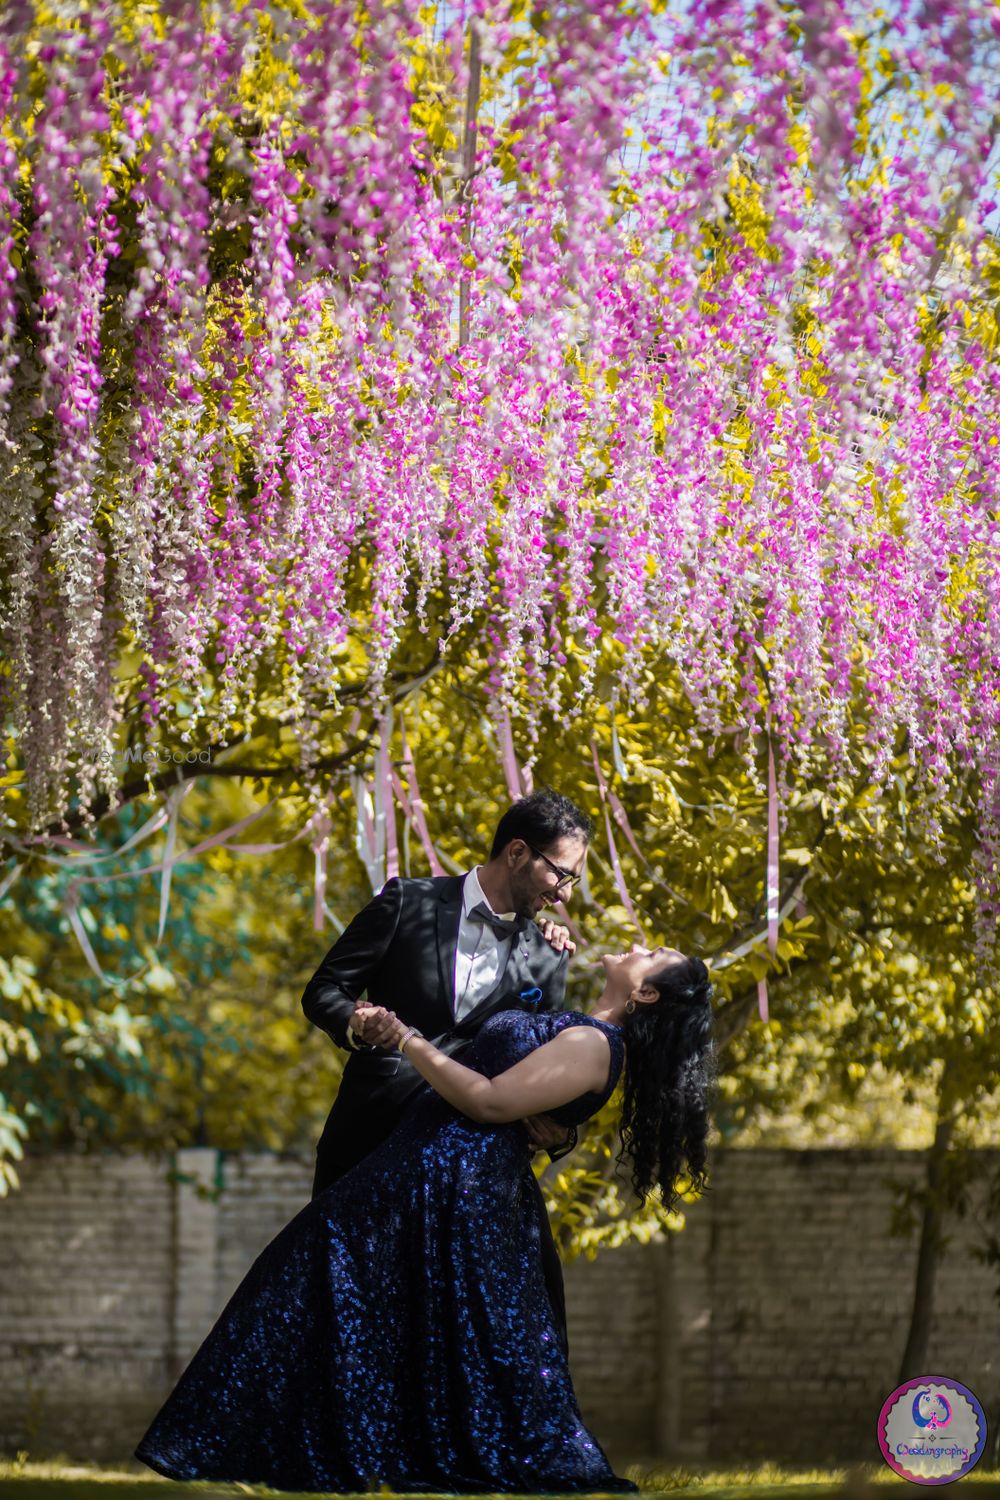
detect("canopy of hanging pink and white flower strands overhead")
[0,0,1000,960]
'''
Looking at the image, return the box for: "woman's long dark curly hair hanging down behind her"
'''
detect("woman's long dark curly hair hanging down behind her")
[618,957,715,1209]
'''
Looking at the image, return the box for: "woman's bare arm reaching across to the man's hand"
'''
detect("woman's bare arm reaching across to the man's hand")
[360,1005,610,1125]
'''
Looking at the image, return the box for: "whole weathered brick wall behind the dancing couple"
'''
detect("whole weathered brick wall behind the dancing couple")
[0,1151,1000,1463]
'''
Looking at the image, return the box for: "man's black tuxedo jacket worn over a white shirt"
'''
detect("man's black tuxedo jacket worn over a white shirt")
[303,876,568,1191]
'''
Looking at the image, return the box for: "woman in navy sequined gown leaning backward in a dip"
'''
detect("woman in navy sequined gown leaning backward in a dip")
[136,948,712,1494]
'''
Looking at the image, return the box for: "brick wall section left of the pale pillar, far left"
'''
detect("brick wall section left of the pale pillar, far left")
[0,1157,175,1454]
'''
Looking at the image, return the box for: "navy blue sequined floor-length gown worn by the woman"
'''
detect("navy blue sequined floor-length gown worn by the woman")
[136,1011,636,1493]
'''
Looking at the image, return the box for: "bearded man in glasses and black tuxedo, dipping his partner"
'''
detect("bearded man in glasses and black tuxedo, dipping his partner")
[303,791,592,1344]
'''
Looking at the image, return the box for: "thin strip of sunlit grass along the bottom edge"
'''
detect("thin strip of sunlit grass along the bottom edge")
[0,1458,1000,1500]
